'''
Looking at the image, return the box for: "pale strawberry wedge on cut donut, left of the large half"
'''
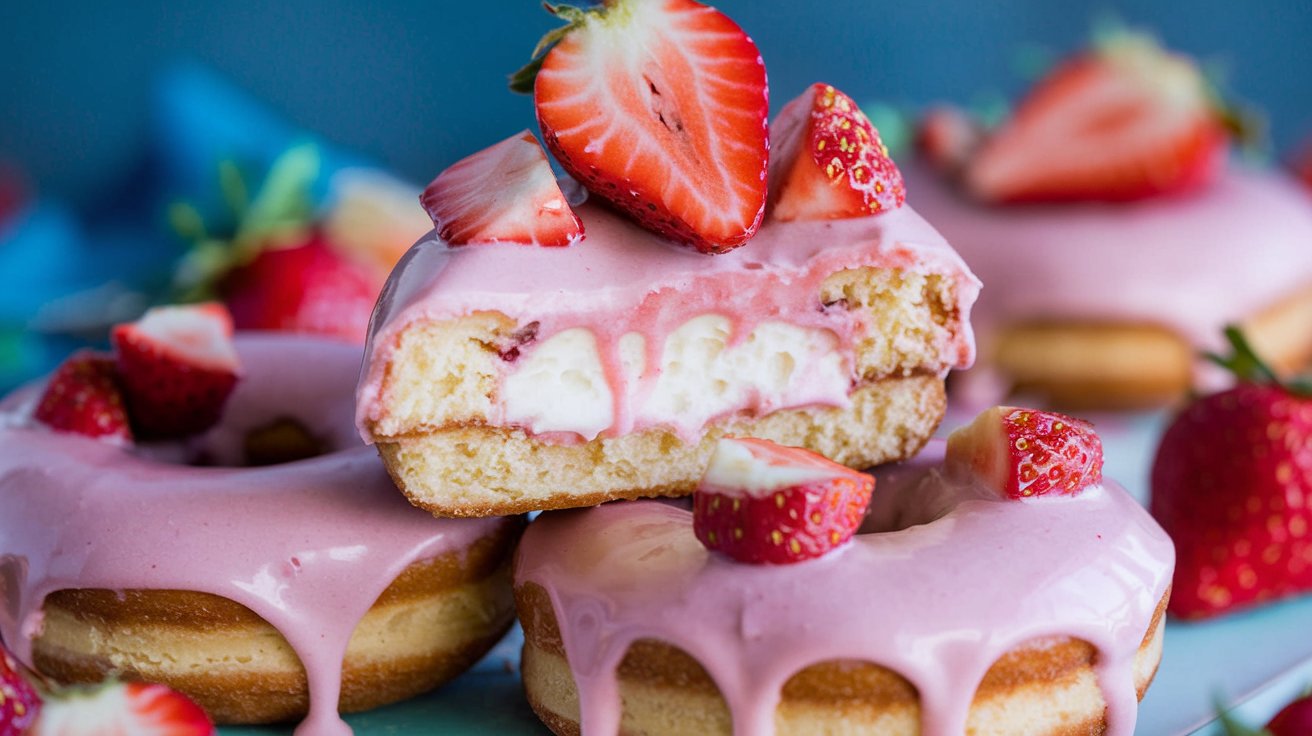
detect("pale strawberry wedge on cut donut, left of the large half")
[419,130,583,245]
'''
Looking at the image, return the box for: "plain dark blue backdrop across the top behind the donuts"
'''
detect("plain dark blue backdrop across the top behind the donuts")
[0,0,1312,207]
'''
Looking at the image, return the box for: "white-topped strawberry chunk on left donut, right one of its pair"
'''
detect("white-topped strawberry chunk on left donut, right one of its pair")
[110,303,240,437]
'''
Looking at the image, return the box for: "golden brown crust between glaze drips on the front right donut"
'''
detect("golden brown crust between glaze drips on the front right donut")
[516,583,1170,736]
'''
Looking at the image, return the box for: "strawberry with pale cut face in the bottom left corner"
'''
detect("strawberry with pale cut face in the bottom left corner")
[31,682,215,736]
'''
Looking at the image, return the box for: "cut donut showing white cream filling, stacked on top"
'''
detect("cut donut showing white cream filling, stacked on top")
[357,198,979,516]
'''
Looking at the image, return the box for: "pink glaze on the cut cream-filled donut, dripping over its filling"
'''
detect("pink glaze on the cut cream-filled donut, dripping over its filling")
[356,198,980,442]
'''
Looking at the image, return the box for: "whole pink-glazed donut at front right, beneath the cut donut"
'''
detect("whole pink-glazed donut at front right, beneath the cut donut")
[514,441,1173,736]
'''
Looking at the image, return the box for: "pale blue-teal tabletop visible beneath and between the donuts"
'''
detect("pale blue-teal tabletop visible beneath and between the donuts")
[220,412,1312,736]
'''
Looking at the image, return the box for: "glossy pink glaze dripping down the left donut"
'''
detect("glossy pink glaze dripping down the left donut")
[0,336,505,736]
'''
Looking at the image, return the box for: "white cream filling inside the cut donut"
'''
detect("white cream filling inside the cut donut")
[500,314,851,440]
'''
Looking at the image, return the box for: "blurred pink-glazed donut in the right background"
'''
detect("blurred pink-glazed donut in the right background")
[905,164,1312,408]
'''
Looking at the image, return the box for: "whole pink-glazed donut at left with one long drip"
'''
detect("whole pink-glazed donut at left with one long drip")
[0,335,522,733]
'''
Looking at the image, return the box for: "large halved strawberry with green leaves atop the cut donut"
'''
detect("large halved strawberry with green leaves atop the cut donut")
[513,0,768,253]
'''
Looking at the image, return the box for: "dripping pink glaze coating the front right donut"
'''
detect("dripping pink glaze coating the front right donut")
[514,441,1174,736]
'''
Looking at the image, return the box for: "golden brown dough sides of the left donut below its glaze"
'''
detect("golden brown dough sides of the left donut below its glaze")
[33,520,523,724]
